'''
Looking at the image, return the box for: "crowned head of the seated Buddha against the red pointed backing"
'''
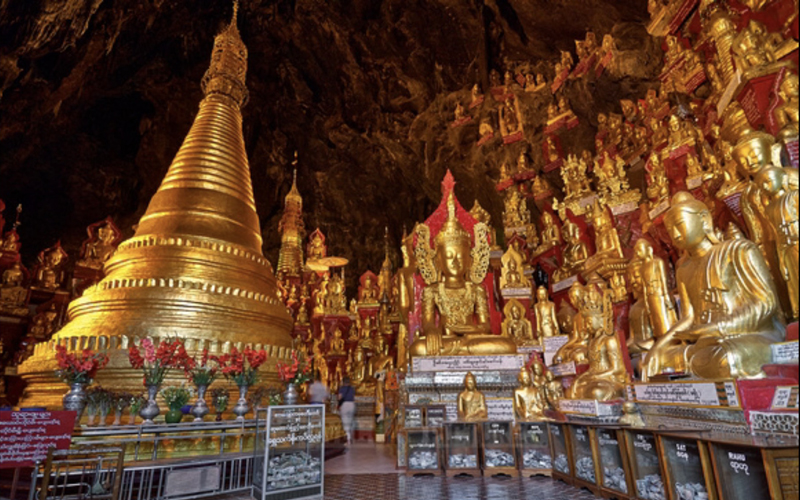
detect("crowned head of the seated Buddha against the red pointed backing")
[434,192,471,282]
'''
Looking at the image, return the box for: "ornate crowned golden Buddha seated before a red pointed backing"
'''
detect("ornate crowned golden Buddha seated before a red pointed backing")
[409,191,516,356]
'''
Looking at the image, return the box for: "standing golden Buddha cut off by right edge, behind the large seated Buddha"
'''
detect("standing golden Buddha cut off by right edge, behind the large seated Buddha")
[755,167,800,319]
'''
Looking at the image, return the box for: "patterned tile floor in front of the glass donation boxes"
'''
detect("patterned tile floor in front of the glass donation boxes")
[325,474,595,500]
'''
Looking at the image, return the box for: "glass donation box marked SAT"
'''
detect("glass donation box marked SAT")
[658,434,717,500]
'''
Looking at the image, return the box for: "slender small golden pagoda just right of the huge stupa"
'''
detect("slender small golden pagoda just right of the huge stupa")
[277,158,306,276]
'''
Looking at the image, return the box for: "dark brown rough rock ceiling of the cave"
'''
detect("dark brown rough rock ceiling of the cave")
[0,0,660,286]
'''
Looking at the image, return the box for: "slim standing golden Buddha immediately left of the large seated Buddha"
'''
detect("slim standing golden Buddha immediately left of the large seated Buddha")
[633,238,677,338]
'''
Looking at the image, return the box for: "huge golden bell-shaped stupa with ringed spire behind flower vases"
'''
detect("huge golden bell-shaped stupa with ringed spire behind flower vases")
[18,3,292,406]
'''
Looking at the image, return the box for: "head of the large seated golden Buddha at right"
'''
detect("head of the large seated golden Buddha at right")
[664,191,718,252]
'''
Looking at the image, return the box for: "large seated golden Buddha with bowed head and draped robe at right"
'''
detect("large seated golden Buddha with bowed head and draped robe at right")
[642,192,785,380]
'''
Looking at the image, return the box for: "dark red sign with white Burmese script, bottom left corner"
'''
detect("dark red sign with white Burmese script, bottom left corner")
[0,411,75,468]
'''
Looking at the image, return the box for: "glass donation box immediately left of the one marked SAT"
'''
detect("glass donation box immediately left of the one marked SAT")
[624,429,667,500]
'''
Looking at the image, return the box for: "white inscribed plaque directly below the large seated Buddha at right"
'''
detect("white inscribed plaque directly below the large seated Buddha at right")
[633,381,739,407]
